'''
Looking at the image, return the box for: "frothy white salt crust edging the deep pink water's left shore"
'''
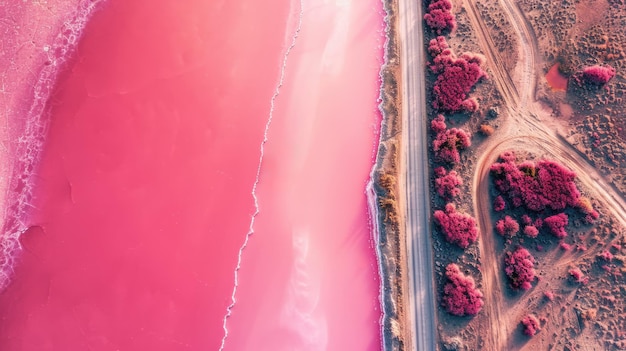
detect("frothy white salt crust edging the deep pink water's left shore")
[0,0,104,291]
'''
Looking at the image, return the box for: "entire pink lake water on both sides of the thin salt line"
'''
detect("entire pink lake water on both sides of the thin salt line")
[0,0,382,351]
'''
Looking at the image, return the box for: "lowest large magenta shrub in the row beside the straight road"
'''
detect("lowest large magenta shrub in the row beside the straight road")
[442,263,483,316]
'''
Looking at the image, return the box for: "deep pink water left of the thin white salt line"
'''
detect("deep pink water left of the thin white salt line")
[0,0,289,351]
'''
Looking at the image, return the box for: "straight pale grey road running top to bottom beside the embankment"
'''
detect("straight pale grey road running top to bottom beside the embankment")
[399,0,436,350]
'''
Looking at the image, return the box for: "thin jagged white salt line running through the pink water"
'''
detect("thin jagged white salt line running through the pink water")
[219,0,303,351]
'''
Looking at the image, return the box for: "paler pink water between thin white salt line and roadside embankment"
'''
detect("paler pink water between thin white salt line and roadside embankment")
[225,0,383,351]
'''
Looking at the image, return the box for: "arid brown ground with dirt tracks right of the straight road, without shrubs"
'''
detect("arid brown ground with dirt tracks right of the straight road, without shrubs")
[414,0,626,350]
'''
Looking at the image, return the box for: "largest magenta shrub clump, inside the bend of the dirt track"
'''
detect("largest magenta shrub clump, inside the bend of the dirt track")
[491,153,580,212]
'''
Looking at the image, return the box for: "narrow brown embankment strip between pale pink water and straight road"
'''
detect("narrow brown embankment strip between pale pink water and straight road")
[373,0,411,351]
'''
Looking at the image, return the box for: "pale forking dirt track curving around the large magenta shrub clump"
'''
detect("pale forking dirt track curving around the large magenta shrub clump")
[464,0,626,350]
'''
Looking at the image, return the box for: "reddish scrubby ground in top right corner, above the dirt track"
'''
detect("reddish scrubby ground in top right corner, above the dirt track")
[520,0,626,194]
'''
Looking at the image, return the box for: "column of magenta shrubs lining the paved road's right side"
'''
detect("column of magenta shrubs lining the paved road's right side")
[424,0,488,350]
